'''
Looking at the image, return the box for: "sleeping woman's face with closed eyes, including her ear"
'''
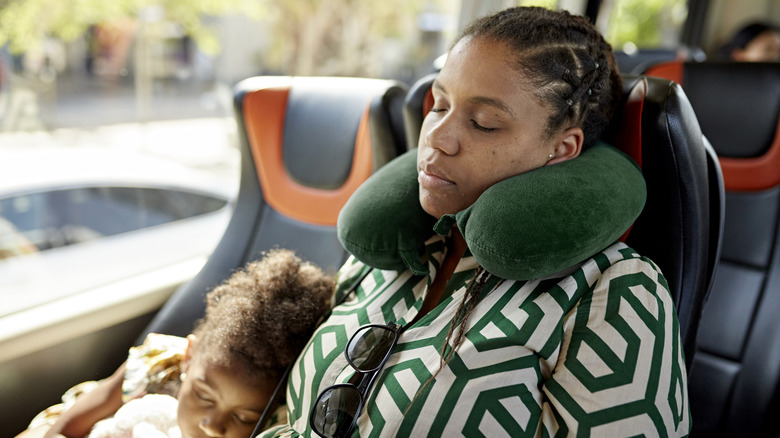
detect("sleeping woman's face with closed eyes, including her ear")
[417,37,582,218]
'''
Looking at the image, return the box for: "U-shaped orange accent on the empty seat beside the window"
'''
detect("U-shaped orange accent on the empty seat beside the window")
[243,85,373,226]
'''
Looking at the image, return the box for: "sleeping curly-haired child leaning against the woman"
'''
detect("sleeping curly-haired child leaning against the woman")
[18,250,334,438]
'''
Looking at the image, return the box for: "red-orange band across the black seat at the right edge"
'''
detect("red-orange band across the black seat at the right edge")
[719,118,780,191]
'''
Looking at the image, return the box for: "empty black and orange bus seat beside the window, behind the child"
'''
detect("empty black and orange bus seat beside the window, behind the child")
[137,76,406,342]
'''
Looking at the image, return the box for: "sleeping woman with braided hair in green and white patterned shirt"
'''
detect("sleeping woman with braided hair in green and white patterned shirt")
[261,8,690,437]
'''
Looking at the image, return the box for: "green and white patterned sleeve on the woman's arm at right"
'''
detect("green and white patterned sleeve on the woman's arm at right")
[545,244,690,436]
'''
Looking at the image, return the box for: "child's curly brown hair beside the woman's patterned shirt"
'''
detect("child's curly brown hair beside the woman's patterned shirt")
[193,250,335,379]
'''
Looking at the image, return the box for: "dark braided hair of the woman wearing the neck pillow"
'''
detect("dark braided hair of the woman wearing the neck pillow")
[456,7,621,148]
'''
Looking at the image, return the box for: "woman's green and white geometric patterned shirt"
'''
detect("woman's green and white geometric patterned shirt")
[261,236,690,437]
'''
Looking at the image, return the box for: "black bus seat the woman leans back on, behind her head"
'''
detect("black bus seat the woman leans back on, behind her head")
[404,74,723,368]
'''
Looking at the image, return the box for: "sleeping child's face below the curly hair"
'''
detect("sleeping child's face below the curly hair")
[177,342,275,438]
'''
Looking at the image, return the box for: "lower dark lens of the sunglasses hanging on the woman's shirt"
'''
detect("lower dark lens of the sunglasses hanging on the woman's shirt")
[311,386,360,438]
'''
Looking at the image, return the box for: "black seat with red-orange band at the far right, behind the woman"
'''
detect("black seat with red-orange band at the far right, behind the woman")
[647,62,780,437]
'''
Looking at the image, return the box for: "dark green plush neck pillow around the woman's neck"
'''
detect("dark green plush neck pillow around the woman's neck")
[337,144,646,280]
